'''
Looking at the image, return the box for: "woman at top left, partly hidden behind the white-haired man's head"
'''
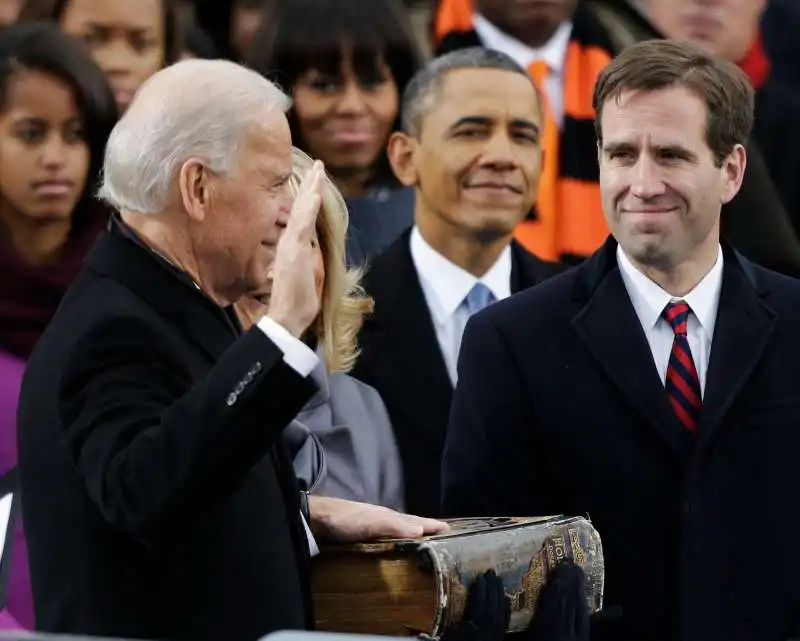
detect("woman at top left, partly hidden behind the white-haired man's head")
[18,0,184,112]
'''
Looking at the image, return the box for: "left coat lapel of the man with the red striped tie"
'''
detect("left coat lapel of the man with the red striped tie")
[572,239,694,460]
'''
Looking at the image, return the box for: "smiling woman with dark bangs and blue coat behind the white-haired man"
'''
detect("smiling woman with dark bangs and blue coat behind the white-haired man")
[248,0,422,264]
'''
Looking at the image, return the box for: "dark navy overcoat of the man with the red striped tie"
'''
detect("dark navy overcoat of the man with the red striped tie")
[442,239,800,641]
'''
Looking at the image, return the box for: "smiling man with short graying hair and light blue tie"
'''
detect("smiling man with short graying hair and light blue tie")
[354,48,559,516]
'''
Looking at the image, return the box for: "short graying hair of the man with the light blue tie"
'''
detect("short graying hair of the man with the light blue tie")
[400,47,541,137]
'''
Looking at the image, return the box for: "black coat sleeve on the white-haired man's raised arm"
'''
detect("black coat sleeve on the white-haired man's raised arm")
[58,318,314,544]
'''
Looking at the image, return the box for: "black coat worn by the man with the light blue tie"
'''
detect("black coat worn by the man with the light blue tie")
[352,230,562,516]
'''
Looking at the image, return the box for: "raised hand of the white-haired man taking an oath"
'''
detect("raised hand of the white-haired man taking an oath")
[267,161,325,338]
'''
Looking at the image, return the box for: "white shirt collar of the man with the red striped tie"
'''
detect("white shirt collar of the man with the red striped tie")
[617,245,724,340]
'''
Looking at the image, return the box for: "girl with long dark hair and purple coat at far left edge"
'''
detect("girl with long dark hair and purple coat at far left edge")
[0,23,117,629]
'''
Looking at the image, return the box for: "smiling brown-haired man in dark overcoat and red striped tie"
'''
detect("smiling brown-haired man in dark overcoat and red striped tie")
[443,40,800,641]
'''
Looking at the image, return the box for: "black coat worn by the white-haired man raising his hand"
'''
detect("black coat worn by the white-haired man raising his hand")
[19,224,314,641]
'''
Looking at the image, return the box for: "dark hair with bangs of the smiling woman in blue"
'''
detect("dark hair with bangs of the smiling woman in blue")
[247,0,423,190]
